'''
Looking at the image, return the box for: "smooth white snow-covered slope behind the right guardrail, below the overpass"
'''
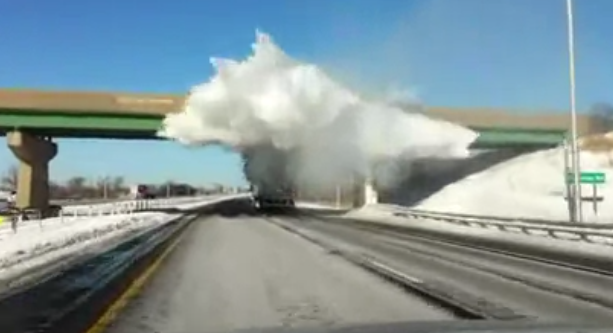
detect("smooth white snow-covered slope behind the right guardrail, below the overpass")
[416,148,613,222]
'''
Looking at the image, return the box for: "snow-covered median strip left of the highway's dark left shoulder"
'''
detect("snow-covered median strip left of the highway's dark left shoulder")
[0,196,244,292]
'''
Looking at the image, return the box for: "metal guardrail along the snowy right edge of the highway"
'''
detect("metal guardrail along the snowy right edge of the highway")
[372,205,613,246]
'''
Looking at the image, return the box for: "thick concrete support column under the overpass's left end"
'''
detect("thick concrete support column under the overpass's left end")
[7,131,57,212]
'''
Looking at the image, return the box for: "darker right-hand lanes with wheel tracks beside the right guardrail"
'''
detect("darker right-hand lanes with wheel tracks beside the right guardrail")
[277,217,613,323]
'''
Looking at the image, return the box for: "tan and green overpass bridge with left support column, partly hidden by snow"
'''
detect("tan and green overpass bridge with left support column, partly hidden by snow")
[0,89,591,209]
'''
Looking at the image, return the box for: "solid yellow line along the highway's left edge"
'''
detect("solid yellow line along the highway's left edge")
[85,226,187,333]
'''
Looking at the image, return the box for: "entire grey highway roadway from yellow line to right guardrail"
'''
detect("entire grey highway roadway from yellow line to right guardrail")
[98,204,613,333]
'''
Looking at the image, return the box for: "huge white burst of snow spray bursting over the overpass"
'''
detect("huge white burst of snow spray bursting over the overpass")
[158,31,477,189]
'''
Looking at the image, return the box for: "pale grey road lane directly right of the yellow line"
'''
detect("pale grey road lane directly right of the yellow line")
[108,216,453,333]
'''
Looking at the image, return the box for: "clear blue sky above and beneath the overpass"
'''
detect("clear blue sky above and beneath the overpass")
[0,0,613,184]
